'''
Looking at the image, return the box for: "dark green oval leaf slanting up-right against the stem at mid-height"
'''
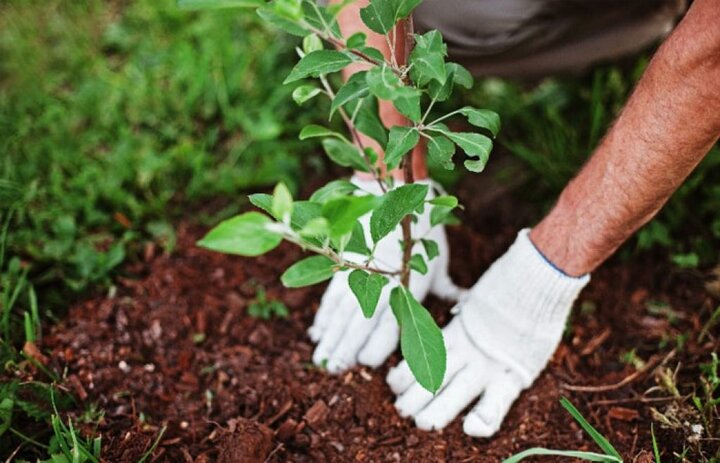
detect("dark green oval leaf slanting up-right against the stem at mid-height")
[370,183,428,243]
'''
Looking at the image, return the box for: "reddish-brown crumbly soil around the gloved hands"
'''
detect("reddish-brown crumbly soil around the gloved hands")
[42,176,718,462]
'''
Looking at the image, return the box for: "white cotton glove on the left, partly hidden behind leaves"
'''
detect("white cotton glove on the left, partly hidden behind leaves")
[308,177,465,373]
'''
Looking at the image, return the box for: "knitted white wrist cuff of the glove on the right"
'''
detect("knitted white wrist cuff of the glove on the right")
[460,229,590,385]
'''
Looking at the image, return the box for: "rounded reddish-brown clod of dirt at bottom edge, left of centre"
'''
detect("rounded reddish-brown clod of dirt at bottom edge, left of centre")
[218,418,273,463]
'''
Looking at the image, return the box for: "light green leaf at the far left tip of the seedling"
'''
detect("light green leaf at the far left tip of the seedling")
[197,212,282,256]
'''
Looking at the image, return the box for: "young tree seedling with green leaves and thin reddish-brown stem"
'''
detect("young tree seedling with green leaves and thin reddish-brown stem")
[187,0,500,392]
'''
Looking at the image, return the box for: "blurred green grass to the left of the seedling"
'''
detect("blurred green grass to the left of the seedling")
[0,0,326,461]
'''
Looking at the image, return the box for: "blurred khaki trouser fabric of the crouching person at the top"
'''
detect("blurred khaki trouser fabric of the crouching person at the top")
[413,0,687,77]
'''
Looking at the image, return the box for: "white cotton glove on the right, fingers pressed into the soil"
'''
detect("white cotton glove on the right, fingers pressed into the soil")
[387,229,590,437]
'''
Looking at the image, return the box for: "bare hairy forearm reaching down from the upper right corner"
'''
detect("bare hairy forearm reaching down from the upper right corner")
[530,0,720,275]
